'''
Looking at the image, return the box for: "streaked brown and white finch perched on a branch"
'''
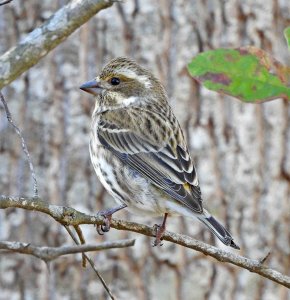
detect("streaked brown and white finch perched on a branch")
[80,57,240,249]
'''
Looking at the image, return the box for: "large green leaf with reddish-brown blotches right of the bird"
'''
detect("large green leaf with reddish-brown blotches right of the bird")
[188,47,290,103]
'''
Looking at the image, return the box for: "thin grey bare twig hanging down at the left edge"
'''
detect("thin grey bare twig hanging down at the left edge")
[0,91,38,197]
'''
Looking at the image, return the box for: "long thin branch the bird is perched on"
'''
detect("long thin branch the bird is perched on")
[0,196,290,288]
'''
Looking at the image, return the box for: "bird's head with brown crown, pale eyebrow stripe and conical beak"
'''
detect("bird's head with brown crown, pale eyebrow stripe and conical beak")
[80,57,167,110]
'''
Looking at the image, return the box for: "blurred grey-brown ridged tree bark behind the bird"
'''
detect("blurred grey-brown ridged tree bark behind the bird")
[0,0,290,300]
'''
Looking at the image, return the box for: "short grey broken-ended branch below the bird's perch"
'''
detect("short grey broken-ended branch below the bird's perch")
[0,239,135,262]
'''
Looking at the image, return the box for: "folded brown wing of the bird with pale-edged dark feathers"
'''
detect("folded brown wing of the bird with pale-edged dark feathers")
[98,109,202,213]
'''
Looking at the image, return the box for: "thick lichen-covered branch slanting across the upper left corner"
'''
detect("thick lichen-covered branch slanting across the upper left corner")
[0,0,118,89]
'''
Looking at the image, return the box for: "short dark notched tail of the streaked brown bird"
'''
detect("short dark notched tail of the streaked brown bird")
[198,211,240,249]
